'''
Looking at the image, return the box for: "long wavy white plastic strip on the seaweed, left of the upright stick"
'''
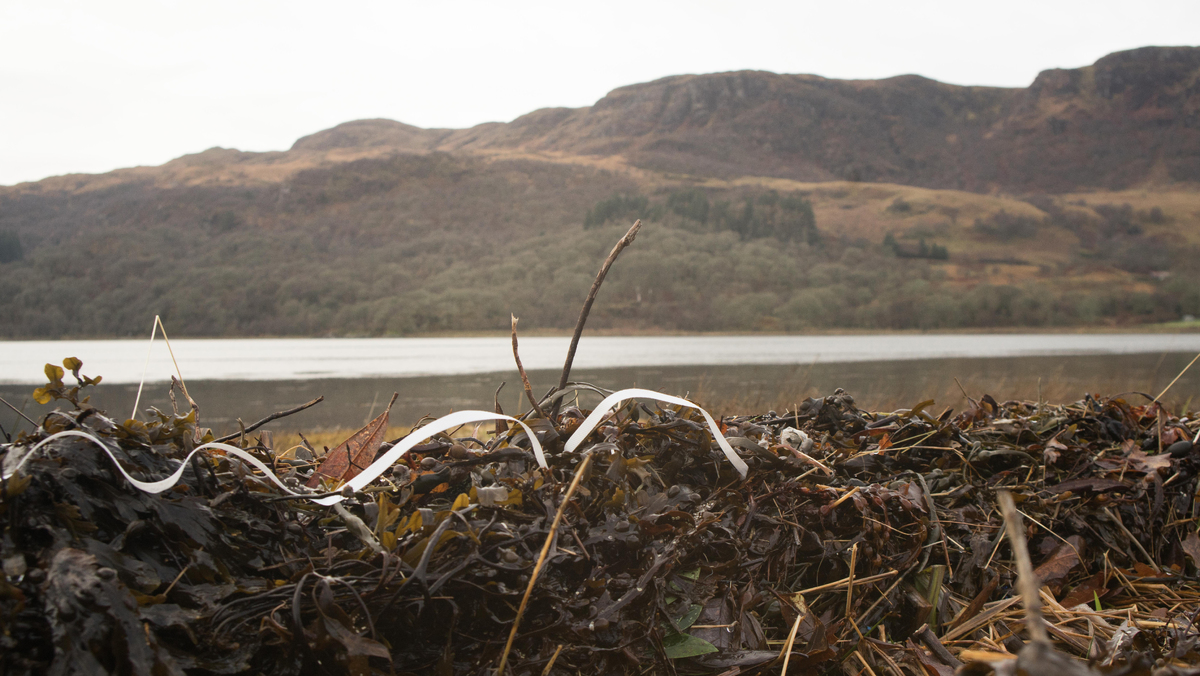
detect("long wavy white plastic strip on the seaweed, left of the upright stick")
[0,411,547,505]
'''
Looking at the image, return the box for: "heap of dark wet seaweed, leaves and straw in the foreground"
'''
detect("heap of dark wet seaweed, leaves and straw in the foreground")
[0,363,1200,676]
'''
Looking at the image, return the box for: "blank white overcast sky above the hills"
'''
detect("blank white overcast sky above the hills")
[0,0,1200,185]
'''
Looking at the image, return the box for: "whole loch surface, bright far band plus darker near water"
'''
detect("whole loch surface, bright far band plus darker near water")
[0,334,1200,439]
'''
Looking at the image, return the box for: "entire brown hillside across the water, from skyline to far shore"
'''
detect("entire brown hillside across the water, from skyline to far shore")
[0,48,1200,337]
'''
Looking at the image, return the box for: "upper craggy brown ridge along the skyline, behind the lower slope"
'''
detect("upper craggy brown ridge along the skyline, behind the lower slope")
[9,47,1200,193]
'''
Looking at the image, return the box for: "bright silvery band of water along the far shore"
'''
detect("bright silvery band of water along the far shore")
[0,334,1200,384]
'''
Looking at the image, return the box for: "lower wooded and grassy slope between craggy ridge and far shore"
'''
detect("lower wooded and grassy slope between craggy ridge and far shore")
[0,149,1200,337]
